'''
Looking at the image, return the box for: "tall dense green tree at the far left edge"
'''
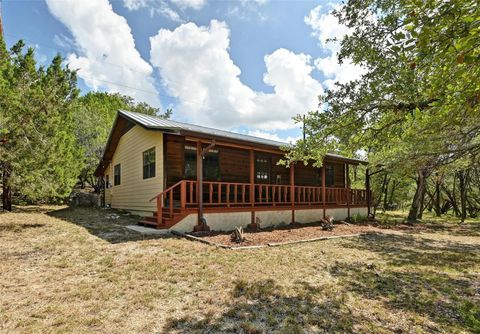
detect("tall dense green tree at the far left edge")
[0,40,82,210]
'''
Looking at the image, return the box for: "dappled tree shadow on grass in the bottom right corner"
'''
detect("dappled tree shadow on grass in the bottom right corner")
[330,263,480,333]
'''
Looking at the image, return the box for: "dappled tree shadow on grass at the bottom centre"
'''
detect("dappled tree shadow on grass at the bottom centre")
[163,280,366,334]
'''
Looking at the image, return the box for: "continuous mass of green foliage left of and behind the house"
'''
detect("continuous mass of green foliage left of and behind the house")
[0,39,172,202]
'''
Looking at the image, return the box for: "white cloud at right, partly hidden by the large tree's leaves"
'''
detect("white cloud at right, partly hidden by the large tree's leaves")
[304,6,364,89]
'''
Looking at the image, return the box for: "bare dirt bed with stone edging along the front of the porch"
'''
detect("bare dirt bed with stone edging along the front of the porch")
[191,224,382,246]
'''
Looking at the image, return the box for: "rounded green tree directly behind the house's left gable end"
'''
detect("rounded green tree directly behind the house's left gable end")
[74,92,172,191]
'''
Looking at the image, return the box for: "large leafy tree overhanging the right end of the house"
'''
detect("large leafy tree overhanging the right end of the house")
[287,0,480,221]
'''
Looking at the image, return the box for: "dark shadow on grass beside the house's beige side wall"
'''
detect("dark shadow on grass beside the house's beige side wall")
[47,207,178,243]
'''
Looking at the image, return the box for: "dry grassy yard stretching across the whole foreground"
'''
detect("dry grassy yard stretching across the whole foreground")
[0,207,480,333]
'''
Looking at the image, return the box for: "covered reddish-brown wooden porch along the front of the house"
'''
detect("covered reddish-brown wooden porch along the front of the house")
[146,135,371,228]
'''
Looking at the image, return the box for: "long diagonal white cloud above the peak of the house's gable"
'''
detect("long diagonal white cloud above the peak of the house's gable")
[47,0,160,107]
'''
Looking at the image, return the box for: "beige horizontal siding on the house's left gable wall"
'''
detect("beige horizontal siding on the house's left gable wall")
[105,125,163,212]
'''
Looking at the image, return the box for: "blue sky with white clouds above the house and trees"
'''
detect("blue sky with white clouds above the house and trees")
[2,0,362,142]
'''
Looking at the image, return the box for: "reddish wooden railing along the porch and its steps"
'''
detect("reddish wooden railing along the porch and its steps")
[150,180,367,220]
